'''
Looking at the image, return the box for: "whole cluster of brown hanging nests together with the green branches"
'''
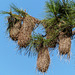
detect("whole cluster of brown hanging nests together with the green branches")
[2,0,75,72]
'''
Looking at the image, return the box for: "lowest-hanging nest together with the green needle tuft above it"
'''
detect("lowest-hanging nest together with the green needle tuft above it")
[31,35,50,72]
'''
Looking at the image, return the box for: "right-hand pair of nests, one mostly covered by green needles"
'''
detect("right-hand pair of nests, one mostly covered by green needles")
[42,19,72,57]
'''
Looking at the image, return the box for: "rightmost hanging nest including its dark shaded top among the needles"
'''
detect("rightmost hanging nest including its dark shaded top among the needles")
[59,21,72,58]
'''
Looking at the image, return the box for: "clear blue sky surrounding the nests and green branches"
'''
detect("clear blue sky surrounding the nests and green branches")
[0,0,75,75]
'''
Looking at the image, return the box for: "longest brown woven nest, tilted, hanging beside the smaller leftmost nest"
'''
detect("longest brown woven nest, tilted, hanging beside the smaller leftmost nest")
[18,16,37,47]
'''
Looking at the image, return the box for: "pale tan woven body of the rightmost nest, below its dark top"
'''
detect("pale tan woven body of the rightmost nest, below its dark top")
[59,32,71,57]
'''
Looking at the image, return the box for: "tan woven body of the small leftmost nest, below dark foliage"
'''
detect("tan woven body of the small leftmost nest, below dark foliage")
[9,21,21,41]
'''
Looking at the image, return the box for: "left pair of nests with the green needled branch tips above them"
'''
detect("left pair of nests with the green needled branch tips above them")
[2,4,40,48]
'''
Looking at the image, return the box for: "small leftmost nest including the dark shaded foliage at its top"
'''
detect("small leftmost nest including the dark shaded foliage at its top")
[7,16,21,41]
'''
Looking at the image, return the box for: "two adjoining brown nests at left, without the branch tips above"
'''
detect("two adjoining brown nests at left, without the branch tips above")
[7,15,39,47]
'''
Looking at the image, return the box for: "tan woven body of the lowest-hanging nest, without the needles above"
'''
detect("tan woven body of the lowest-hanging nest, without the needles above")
[37,48,50,72]
